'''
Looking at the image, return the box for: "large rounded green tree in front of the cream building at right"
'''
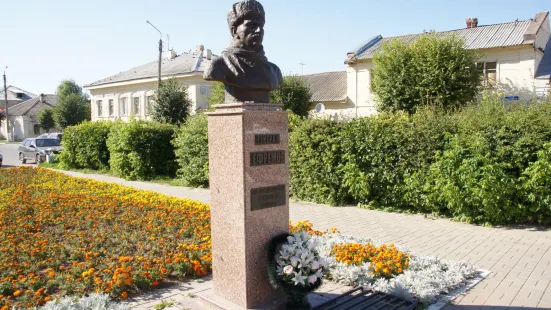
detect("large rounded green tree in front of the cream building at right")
[371,33,479,113]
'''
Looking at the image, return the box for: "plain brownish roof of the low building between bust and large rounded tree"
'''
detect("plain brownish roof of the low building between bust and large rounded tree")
[300,71,347,102]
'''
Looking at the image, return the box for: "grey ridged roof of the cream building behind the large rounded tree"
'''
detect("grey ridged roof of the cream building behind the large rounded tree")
[348,20,532,59]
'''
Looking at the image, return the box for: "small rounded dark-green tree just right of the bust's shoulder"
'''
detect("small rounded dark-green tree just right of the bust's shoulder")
[270,75,312,116]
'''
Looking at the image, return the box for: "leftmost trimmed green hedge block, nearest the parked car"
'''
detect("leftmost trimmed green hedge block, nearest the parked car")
[59,122,113,170]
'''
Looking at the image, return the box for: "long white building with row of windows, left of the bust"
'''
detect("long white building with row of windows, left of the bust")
[84,45,213,121]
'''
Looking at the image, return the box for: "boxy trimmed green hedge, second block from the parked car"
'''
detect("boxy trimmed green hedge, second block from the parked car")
[107,121,176,180]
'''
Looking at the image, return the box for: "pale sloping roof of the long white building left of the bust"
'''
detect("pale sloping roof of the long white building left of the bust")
[84,51,216,87]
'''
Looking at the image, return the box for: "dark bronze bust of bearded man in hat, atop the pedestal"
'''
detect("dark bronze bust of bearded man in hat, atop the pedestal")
[203,0,283,103]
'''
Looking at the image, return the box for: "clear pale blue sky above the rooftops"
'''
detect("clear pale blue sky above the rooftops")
[0,0,551,94]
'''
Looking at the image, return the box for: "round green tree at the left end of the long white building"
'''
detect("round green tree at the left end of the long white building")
[53,93,91,129]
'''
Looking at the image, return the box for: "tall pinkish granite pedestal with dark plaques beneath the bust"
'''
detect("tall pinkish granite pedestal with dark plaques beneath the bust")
[208,103,289,309]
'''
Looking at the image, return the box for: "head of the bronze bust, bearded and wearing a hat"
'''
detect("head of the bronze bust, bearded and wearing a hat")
[228,0,265,50]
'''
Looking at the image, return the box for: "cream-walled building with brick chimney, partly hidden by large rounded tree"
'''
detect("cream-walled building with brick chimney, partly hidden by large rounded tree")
[324,12,551,117]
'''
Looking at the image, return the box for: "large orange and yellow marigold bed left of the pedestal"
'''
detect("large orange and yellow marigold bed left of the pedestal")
[0,168,211,310]
